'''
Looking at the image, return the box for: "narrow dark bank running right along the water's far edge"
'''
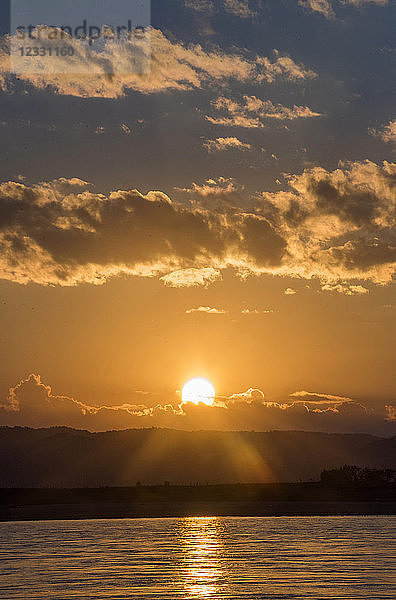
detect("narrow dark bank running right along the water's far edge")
[0,501,396,522]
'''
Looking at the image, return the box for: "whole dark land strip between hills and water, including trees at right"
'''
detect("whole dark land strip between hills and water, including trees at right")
[0,482,396,521]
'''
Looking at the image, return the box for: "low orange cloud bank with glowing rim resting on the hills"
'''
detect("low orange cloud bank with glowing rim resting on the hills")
[0,374,396,435]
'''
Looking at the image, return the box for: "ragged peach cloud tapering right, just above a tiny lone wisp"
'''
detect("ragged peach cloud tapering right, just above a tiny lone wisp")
[206,95,322,129]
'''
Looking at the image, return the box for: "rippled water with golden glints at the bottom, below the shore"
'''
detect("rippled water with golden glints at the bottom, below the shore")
[0,517,396,600]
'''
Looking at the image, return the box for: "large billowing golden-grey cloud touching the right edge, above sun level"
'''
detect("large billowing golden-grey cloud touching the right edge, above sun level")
[262,161,396,292]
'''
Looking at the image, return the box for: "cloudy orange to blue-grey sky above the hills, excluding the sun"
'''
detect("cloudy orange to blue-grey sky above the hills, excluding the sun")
[0,0,396,435]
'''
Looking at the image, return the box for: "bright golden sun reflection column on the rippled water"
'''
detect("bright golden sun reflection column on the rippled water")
[180,517,225,598]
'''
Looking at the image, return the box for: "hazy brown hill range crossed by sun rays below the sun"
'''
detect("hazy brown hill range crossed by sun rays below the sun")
[0,427,396,488]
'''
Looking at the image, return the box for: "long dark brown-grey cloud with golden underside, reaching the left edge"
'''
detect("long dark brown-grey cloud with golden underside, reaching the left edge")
[0,180,285,287]
